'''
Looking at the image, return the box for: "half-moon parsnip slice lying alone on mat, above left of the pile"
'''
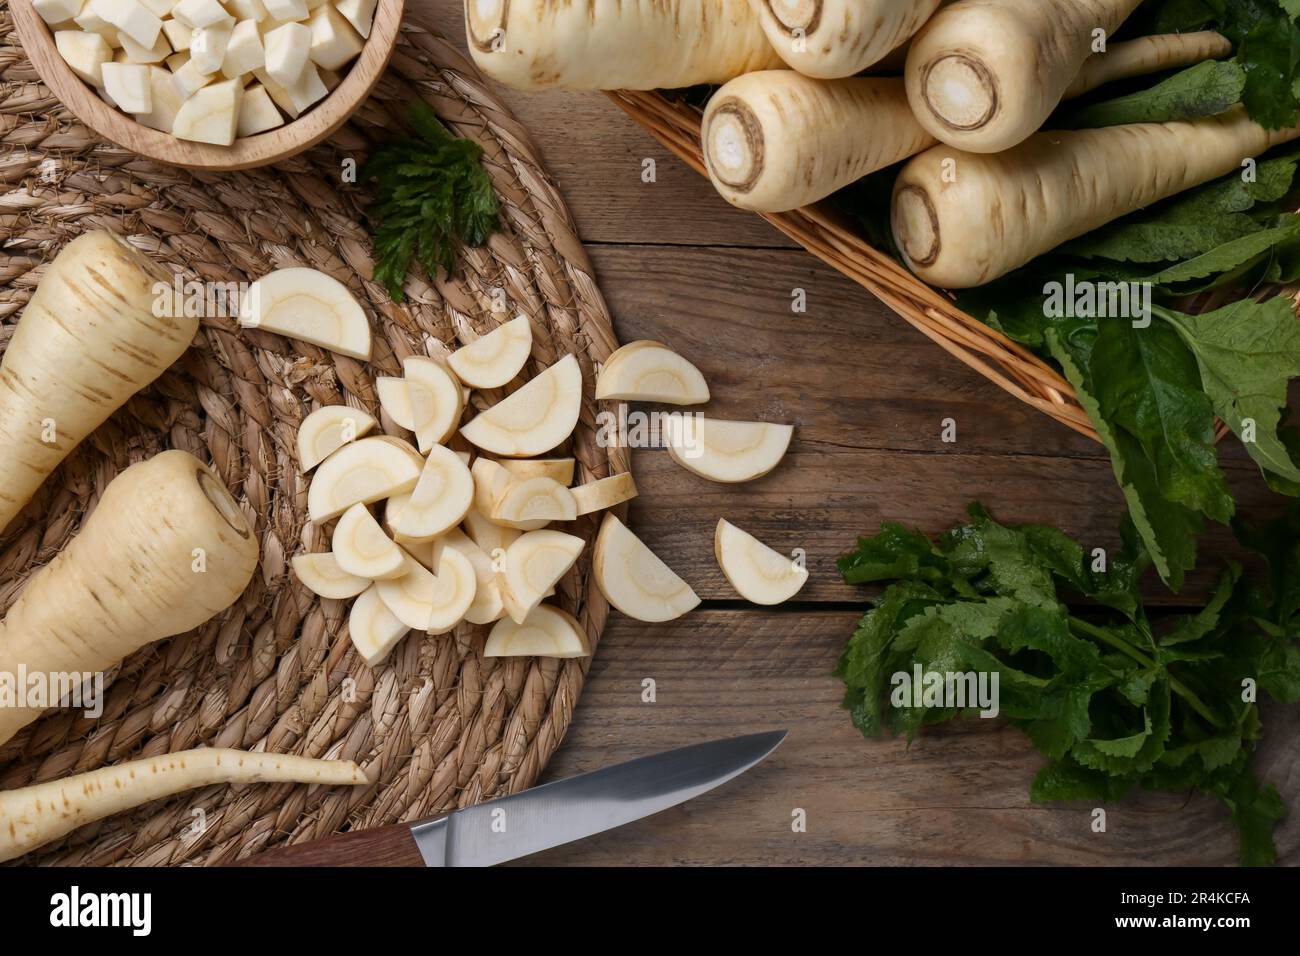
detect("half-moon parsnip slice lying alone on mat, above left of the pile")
[240,267,371,360]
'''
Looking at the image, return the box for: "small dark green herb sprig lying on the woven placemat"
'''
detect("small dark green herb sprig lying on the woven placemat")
[360,100,498,302]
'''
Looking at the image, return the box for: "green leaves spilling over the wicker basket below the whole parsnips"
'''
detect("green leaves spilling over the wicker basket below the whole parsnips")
[958,148,1300,591]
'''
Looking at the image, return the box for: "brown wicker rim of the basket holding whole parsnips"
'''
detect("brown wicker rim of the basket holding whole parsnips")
[610,91,1118,441]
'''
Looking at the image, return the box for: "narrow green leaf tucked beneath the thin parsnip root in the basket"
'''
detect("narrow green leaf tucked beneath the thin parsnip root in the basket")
[1066,60,1247,129]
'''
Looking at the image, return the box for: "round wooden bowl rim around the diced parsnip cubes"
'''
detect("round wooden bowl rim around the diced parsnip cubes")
[9,0,404,170]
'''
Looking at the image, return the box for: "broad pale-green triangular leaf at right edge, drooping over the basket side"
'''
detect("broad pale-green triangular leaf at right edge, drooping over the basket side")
[1160,295,1300,481]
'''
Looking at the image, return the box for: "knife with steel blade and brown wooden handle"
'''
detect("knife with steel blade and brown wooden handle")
[238,731,787,866]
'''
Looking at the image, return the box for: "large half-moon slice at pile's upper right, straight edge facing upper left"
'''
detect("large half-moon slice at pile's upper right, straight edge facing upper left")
[460,355,582,458]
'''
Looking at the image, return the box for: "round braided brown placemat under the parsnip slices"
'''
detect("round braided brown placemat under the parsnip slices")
[0,4,628,865]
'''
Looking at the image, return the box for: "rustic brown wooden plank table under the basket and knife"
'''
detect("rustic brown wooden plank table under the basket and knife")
[421,0,1300,866]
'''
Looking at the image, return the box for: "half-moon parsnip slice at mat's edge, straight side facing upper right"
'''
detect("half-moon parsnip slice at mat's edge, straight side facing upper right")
[593,514,699,623]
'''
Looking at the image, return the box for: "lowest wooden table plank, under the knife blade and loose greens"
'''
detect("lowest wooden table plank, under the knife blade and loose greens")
[521,610,1300,866]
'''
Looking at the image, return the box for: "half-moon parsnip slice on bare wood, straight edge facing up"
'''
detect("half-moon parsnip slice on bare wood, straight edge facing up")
[668,416,794,484]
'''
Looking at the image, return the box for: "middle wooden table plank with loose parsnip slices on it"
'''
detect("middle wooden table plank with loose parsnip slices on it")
[593,247,1283,604]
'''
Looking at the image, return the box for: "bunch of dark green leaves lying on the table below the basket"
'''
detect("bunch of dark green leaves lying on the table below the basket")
[836,505,1300,865]
